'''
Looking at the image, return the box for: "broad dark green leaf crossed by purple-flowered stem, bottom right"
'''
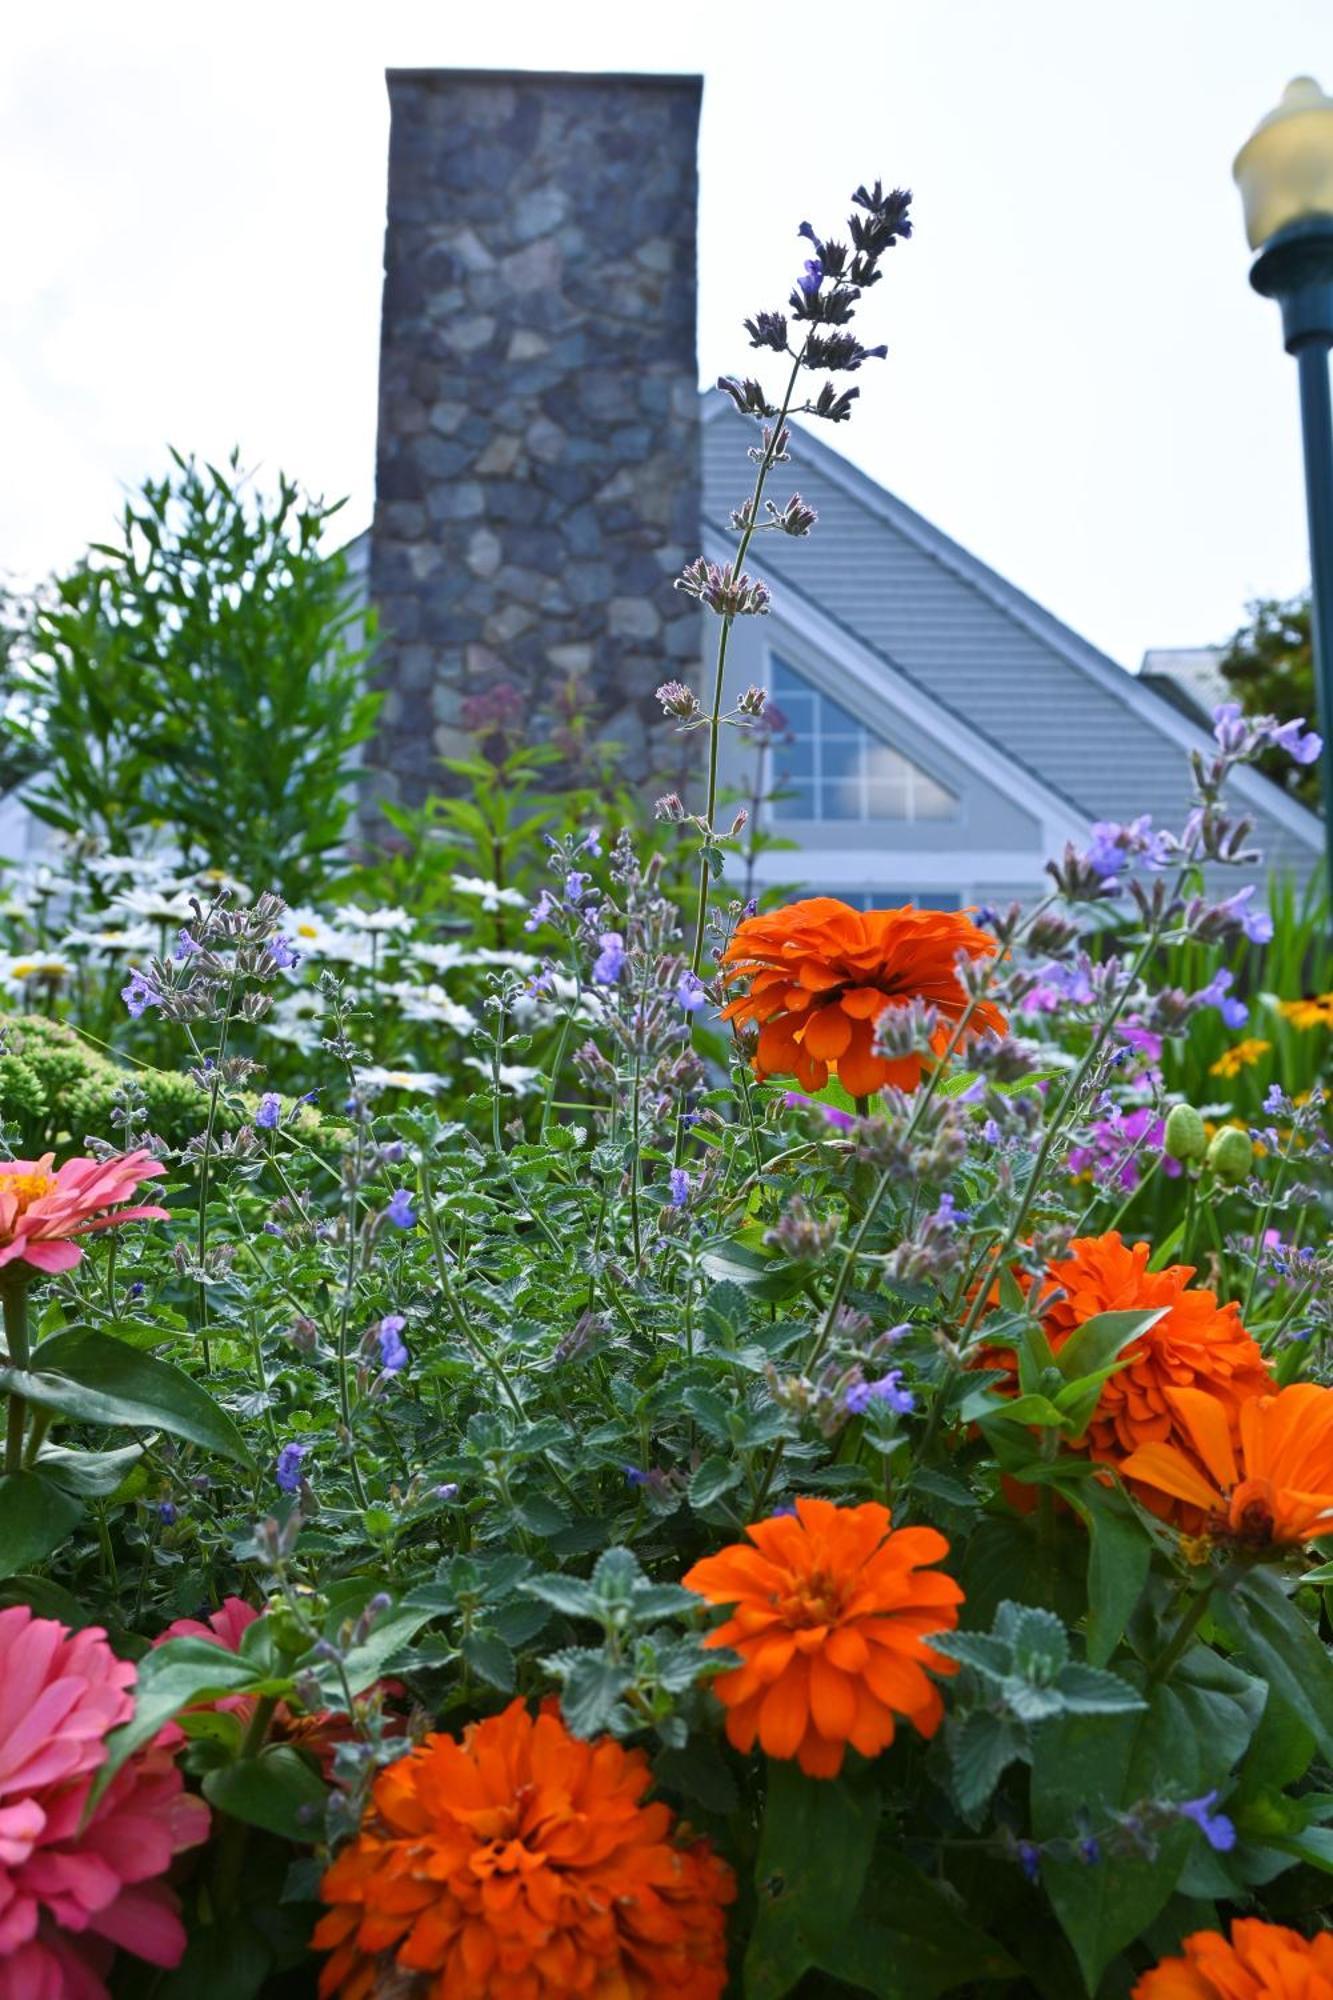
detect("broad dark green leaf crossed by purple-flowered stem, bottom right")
[1031,1688,1199,1994]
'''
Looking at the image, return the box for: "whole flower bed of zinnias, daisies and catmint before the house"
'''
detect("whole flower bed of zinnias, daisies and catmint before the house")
[0,182,1333,2000]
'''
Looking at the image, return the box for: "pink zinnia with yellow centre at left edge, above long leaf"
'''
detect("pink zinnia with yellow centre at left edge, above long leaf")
[0,1148,168,1270]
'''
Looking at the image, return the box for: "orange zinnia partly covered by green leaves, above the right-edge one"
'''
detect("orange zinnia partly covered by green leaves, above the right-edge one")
[977,1230,1275,1532]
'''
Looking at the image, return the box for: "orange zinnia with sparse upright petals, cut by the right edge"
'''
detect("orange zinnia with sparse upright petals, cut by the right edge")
[1121,1382,1333,1548]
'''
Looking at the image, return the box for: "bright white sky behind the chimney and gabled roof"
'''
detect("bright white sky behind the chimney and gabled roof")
[0,0,1333,664]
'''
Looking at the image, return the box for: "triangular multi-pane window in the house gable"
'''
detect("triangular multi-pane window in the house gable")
[769,658,959,822]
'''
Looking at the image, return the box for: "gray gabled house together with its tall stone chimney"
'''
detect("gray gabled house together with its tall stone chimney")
[352,70,1321,908]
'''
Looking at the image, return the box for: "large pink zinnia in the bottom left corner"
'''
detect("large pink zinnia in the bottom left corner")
[0,1604,208,2000]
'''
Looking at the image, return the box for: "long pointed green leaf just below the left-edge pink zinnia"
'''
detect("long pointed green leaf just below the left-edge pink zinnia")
[0,1328,254,1466]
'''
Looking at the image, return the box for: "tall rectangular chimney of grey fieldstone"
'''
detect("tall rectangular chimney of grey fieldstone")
[358,70,703,802]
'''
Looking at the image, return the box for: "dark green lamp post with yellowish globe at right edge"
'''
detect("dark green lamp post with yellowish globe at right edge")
[1233,76,1333,912]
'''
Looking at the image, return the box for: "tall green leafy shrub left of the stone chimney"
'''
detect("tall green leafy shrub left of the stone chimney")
[16,452,378,896]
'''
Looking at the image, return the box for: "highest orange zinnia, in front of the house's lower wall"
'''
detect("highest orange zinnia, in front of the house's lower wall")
[723,896,1005,1098]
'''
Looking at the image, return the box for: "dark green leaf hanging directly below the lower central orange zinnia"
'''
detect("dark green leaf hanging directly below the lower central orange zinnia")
[745,1758,879,2000]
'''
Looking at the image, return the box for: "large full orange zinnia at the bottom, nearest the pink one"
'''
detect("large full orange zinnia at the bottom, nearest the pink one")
[312,1700,735,2000]
